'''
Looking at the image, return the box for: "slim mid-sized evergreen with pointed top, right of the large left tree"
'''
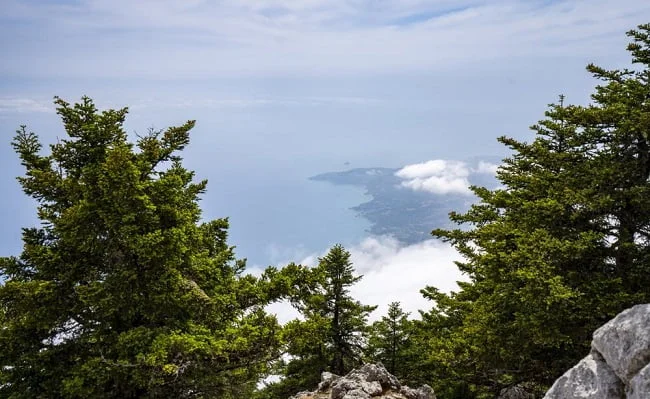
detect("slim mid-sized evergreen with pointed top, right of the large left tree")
[261,245,376,398]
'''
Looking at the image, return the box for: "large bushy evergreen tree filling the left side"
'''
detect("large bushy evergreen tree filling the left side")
[0,97,288,398]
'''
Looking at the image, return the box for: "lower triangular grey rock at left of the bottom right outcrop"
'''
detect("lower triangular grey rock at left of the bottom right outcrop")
[544,353,624,399]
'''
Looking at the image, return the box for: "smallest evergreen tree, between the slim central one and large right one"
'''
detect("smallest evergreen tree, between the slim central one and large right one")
[368,302,413,382]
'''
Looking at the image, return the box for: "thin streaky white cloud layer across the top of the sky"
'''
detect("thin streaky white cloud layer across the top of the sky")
[0,0,650,79]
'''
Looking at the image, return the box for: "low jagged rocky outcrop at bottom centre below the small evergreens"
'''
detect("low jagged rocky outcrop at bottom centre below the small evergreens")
[291,363,436,399]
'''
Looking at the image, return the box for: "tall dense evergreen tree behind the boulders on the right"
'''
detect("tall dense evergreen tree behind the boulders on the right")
[424,25,650,395]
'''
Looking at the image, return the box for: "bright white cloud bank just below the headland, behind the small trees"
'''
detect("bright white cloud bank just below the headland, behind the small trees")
[267,237,466,323]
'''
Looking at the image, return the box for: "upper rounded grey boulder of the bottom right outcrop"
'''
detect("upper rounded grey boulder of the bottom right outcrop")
[591,305,650,384]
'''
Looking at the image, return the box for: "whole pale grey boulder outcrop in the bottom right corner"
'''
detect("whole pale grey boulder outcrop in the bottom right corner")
[544,304,650,399]
